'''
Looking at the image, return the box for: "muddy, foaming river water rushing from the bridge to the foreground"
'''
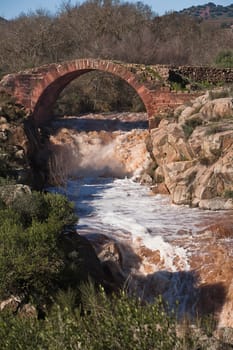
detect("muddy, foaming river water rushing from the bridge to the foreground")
[48,114,233,316]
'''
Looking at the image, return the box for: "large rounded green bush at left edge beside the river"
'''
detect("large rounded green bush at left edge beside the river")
[0,192,77,305]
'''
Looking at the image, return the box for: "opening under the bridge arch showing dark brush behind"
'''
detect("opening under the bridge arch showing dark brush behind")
[53,70,146,116]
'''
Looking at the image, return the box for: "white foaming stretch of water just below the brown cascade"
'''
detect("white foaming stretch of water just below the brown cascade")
[54,177,224,271]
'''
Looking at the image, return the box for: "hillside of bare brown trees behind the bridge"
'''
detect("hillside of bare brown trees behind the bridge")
[0,0,233,73]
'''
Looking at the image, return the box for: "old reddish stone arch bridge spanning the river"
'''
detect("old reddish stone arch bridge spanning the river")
[0,59,233,127]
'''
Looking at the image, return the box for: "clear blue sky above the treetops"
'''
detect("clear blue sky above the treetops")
[0,0,233,19]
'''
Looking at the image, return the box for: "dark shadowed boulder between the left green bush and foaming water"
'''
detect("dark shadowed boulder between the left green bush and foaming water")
[60,232,125,291]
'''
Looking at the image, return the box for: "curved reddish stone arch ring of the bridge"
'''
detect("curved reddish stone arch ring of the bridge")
[30,59,153,126]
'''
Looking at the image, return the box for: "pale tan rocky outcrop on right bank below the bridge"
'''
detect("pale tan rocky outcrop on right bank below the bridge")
[150,93,233,210]
